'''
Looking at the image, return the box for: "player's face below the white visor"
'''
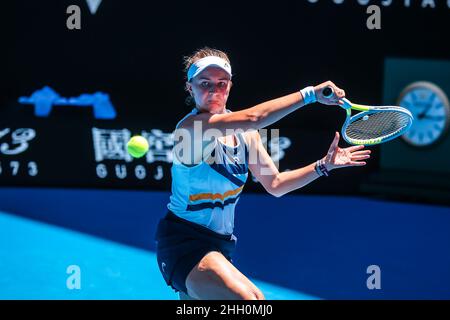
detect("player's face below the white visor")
[188,67,232,113]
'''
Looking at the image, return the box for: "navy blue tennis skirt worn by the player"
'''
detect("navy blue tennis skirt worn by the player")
[155,211,237,294]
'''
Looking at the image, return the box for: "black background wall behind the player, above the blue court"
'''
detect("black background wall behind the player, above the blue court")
[0,0,450,193]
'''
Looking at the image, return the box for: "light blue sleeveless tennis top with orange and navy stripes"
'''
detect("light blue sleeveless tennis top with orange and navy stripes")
[167,108,248,235]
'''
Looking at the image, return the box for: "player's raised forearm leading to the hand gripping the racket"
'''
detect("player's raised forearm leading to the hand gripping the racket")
[247,92,304,129]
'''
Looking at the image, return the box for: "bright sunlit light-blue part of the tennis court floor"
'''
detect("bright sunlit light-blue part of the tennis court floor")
[0,212,315,300]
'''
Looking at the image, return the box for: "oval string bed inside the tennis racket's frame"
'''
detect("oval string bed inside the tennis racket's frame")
[345,111,411,140]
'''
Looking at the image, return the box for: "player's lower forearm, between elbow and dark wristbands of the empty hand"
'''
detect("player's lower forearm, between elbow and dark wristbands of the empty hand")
[272,163,319,197]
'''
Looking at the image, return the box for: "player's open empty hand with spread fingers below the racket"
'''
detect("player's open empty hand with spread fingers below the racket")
[323,132,370,171]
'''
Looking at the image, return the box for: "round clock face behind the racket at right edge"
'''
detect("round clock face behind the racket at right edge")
[398,82,450,147]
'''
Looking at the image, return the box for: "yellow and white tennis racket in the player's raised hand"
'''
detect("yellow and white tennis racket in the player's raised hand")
[322,86,414,145]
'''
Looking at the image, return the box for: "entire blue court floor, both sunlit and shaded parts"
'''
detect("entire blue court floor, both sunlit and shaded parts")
[0,188,450,300]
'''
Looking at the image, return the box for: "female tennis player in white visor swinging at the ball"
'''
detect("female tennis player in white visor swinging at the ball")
[156,48,370,300]
